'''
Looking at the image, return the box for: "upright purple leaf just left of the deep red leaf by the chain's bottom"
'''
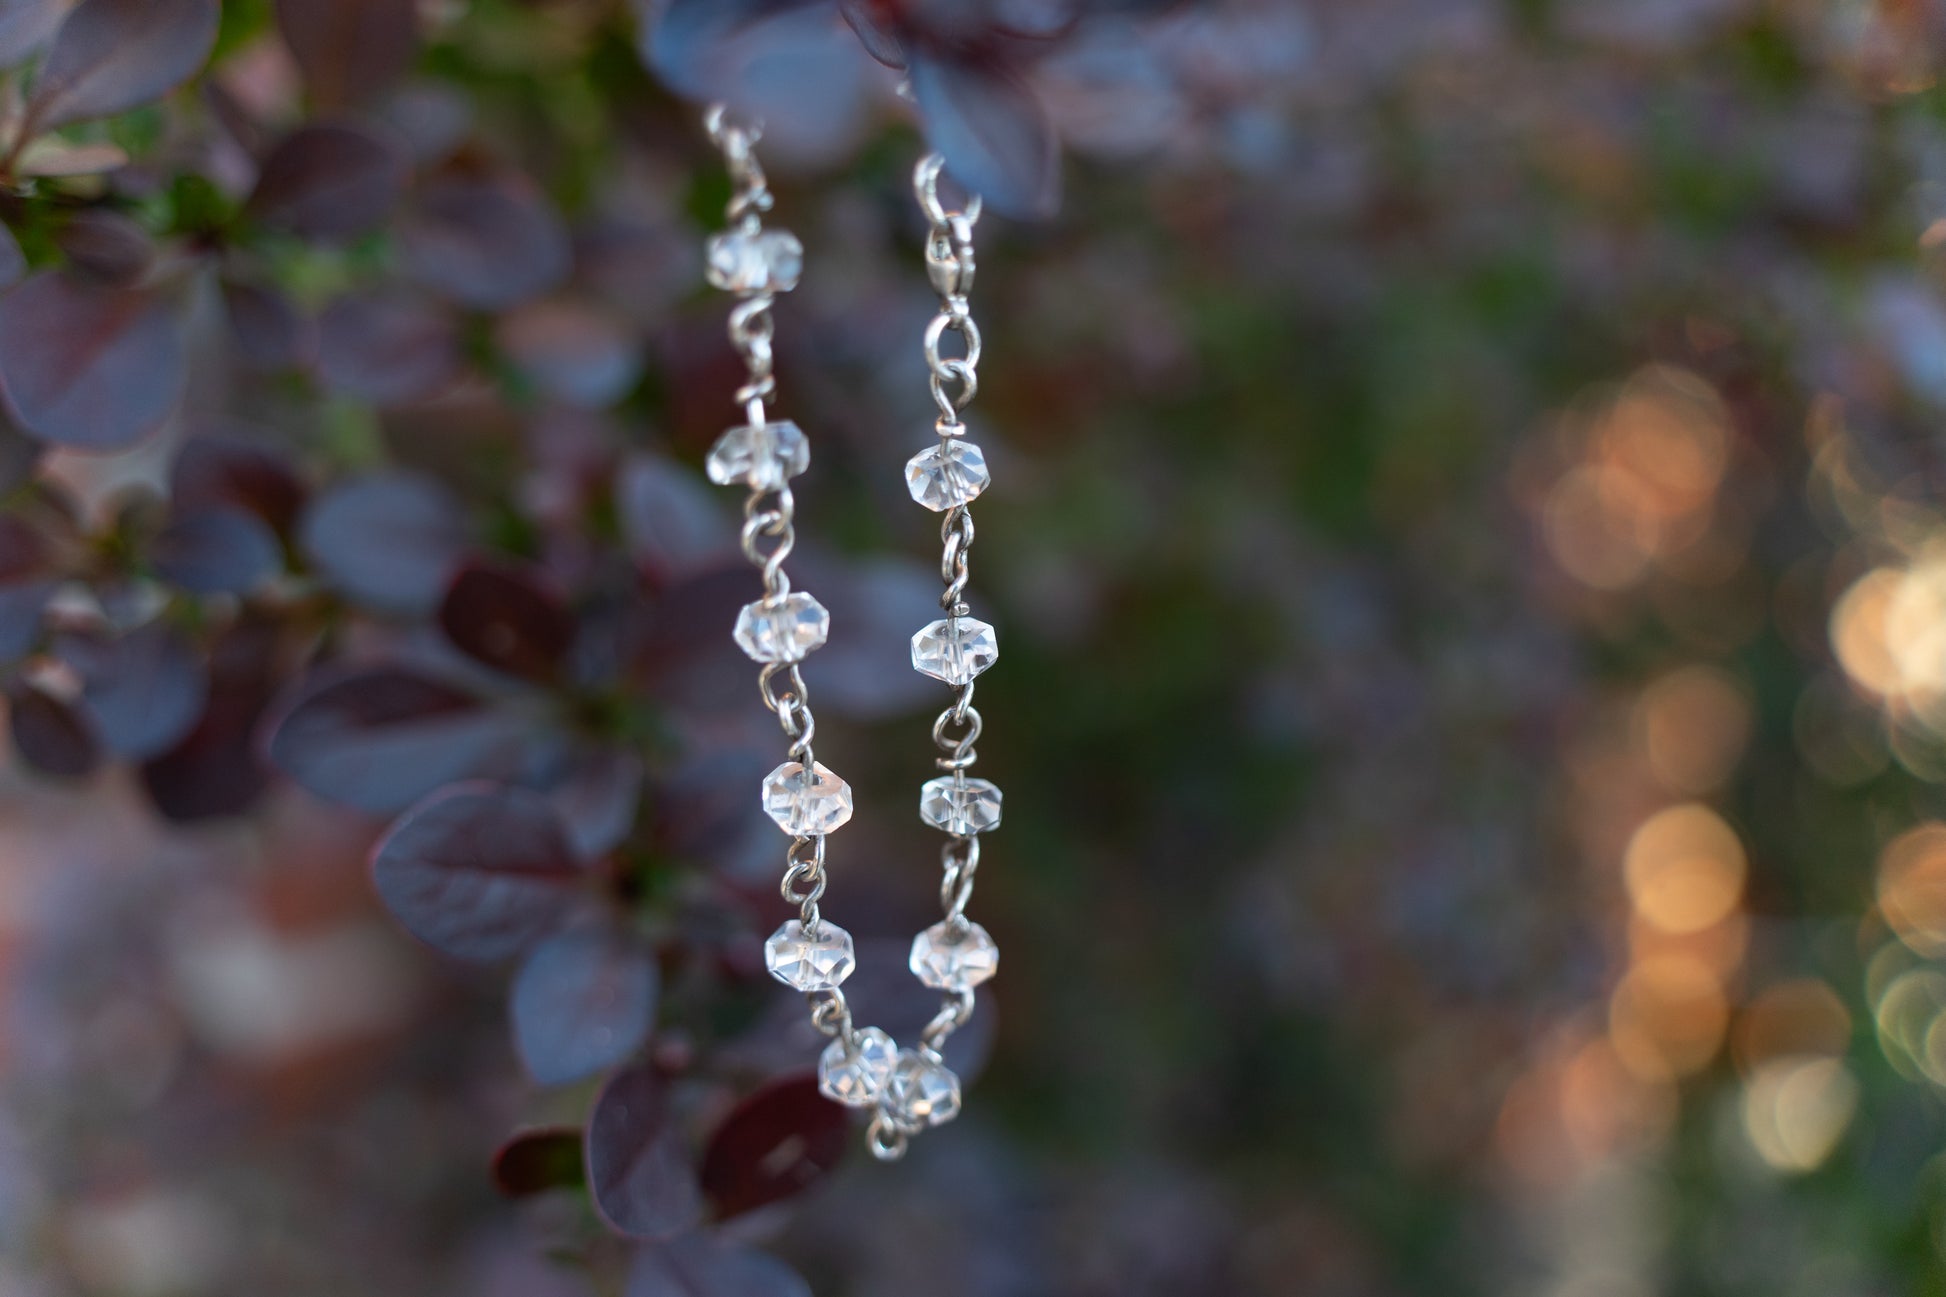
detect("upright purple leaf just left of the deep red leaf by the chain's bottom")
[588,1067,703,1239]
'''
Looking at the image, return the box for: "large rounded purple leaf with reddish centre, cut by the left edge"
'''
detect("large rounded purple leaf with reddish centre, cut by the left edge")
[0,273,183,450]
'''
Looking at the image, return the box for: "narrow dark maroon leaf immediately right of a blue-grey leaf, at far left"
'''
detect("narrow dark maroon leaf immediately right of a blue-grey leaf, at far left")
[142,619,278,824]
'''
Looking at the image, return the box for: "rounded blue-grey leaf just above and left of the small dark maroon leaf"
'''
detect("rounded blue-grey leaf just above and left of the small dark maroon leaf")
[300,473,467,613]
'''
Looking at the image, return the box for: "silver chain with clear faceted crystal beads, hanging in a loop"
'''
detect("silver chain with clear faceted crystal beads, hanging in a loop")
[704,105,1000,1161]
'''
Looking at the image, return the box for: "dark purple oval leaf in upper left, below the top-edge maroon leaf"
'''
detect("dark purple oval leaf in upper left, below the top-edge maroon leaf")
[245,123,405,240]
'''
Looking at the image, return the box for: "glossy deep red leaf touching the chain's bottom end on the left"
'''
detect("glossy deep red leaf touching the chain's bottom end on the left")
[703,1075,850,1219]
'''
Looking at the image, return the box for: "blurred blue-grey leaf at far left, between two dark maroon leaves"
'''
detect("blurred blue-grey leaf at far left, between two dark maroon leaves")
[54,621,210,761]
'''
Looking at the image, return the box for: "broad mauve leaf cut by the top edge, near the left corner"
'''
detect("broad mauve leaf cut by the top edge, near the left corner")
[27,0,218,132]
